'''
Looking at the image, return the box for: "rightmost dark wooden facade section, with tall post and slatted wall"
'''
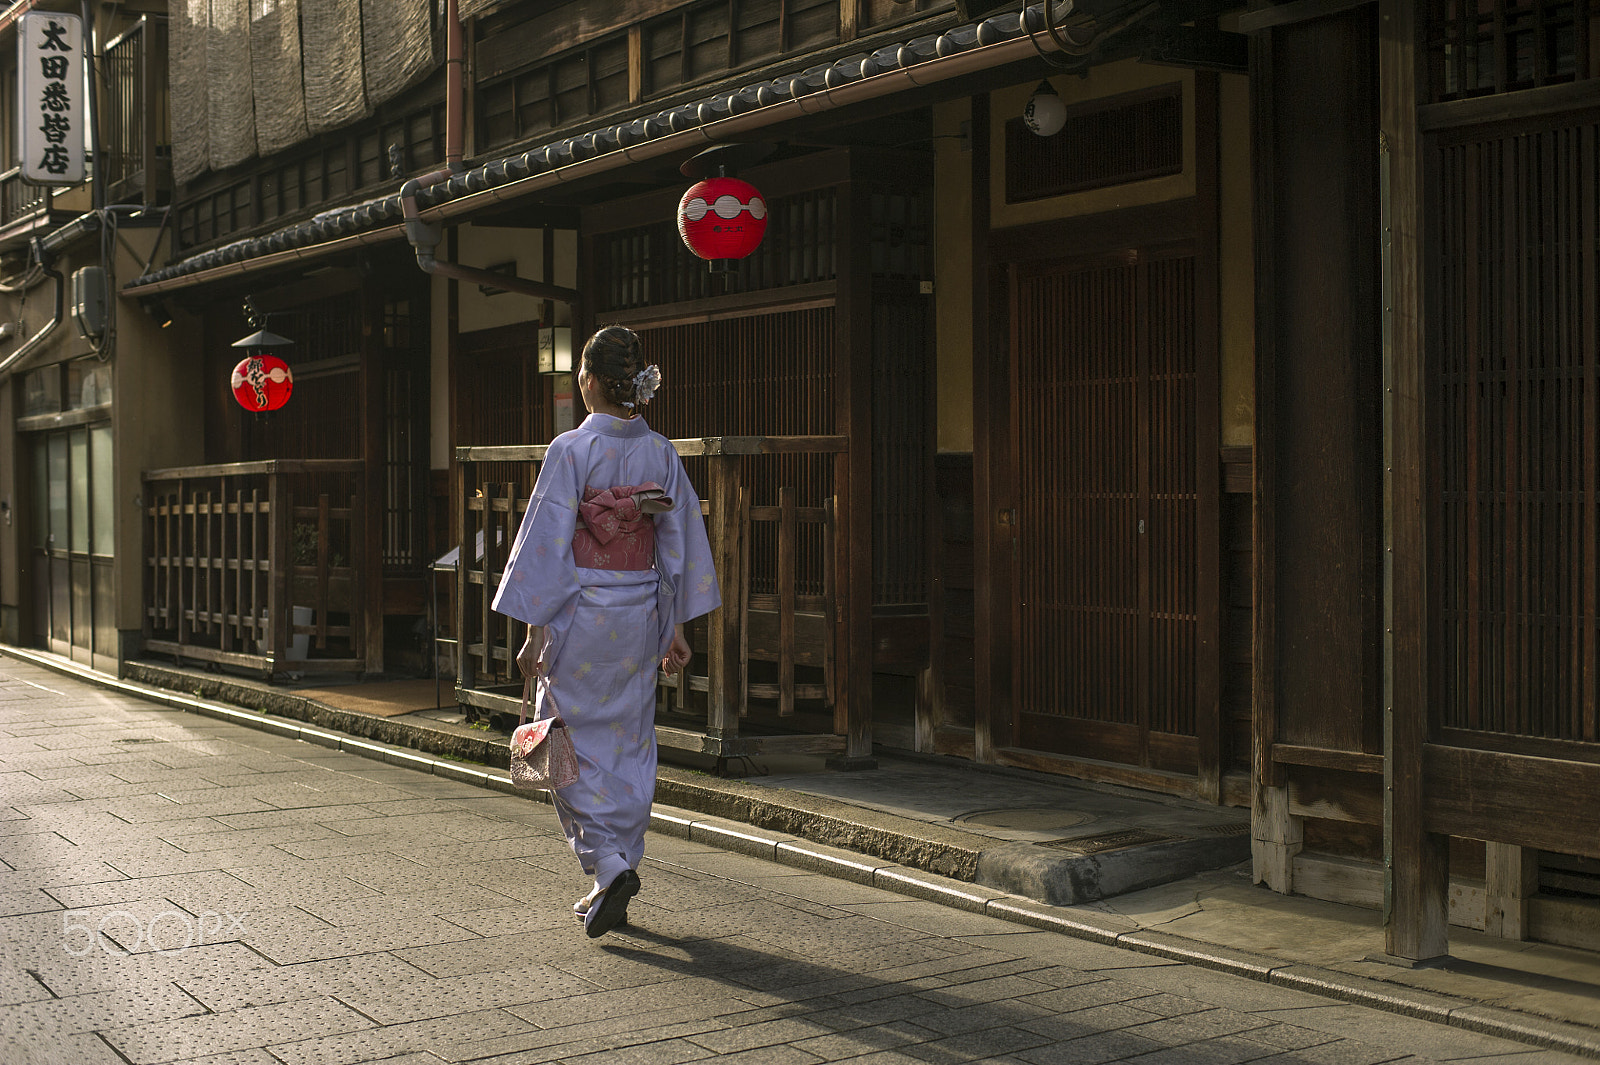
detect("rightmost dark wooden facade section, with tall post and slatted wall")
[1242,0,1600,959]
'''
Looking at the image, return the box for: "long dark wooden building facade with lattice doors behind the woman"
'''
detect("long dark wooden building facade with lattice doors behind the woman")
[0,0,1600,959]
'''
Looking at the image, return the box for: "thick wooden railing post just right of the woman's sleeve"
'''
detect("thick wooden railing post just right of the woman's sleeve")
[706,448,747,745]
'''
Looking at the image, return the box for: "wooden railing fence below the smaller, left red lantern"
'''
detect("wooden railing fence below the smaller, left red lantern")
[144,459,381,678]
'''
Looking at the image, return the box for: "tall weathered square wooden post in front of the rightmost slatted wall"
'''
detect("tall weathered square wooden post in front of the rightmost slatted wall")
[1374,0,1450,963]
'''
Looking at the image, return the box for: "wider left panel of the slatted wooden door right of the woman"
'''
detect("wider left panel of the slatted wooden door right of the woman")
[1013,264,1142,723]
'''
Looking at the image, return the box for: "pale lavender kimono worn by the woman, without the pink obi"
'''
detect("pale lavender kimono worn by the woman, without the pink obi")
[494,414,722,886]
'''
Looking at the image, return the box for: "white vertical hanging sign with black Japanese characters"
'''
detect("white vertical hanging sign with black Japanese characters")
[16,11,85,185]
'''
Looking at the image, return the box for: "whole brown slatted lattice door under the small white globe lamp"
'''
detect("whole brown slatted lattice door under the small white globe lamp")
[1011,253,1211,772]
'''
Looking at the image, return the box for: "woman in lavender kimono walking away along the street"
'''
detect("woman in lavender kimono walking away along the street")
[494,326,722,937]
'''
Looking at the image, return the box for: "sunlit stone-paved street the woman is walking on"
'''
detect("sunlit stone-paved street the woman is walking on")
[0,659,1582,1065]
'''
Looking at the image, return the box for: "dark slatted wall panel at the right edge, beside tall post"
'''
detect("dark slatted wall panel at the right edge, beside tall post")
[1429,118,1600,745]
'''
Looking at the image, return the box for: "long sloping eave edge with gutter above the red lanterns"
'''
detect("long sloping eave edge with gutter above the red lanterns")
[122,5,1054,296]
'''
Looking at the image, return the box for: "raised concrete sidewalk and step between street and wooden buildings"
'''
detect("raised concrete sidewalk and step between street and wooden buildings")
[3,648,1600,1057]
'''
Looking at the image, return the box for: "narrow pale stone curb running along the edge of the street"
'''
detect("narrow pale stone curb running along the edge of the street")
[0,646,1600,1059]
